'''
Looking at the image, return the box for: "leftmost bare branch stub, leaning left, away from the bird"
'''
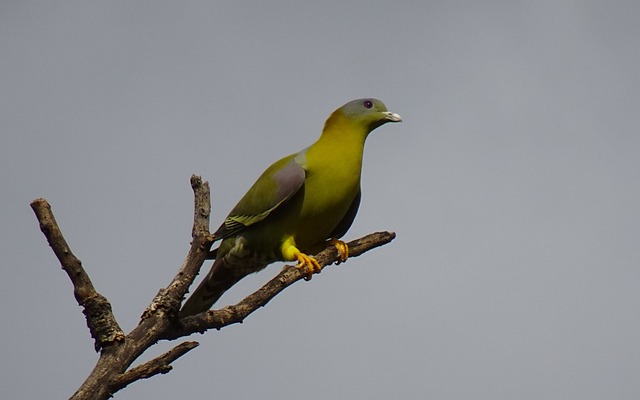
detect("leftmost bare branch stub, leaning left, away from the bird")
[31,199,124,351]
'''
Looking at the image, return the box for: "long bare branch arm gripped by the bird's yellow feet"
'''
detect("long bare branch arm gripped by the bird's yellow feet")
[175,232,396,339]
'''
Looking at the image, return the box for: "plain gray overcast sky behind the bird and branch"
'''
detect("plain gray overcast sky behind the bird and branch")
[0,1,640,399]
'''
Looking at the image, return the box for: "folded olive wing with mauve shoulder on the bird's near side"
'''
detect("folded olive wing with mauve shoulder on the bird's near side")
[214,155,306,239]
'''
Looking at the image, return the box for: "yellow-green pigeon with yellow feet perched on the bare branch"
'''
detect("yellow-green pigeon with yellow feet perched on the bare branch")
[179,98,402,318]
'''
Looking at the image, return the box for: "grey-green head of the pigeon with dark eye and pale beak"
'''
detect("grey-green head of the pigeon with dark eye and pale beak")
[325,98,402,134]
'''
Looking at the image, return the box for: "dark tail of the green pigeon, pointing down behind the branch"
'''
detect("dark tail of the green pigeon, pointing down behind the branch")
[180,257,242,318]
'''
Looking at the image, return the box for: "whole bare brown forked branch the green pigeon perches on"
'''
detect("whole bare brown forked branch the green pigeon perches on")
[31,175,395,400]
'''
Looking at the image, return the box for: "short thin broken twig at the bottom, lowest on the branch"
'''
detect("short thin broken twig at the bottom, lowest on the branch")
[109,342,199,393]
